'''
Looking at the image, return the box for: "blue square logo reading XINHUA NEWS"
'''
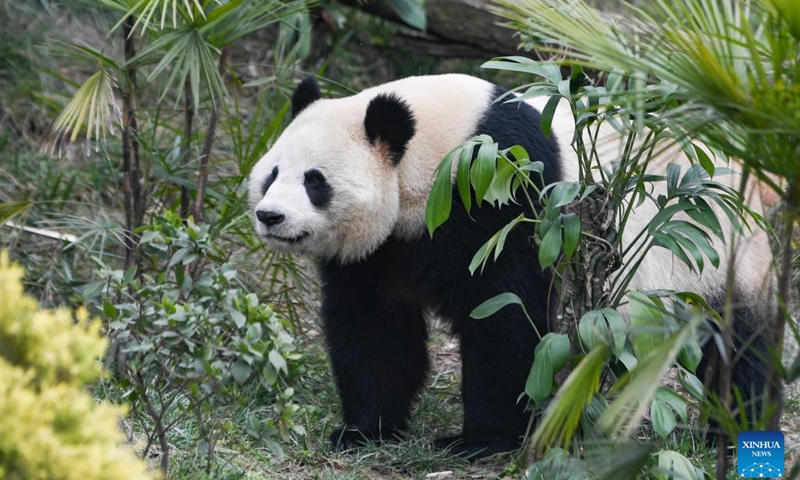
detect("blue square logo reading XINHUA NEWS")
[736,431,784,478]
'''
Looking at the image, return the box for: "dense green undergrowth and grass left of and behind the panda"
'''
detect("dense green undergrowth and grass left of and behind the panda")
[0,0,800,479]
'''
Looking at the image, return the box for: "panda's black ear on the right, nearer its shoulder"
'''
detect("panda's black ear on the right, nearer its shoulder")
[364,93,416,165]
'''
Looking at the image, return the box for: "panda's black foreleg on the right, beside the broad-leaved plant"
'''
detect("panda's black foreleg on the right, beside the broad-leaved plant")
[435,309,536,460]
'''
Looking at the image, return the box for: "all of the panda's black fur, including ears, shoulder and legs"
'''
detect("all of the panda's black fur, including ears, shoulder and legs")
[254,74,776,458]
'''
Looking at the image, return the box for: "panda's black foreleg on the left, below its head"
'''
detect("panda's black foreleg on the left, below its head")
[322,279,429,449]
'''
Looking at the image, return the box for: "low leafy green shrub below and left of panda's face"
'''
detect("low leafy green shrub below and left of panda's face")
[90,212,305,471]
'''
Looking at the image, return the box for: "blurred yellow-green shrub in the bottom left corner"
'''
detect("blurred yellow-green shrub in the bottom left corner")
[0,252,149,480]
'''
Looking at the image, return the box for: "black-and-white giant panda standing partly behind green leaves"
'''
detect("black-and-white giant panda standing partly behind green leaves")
[249,74,771,458]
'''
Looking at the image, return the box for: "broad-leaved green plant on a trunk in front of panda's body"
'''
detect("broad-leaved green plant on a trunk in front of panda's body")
[426,4,792,478]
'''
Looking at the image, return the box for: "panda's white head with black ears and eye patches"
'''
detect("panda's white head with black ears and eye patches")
[249,77,415,262]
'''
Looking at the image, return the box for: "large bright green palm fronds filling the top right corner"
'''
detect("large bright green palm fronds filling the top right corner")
[496,0,800,183]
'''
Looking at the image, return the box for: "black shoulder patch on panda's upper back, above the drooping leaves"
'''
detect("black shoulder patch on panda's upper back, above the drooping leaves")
[474,85,562,183]
